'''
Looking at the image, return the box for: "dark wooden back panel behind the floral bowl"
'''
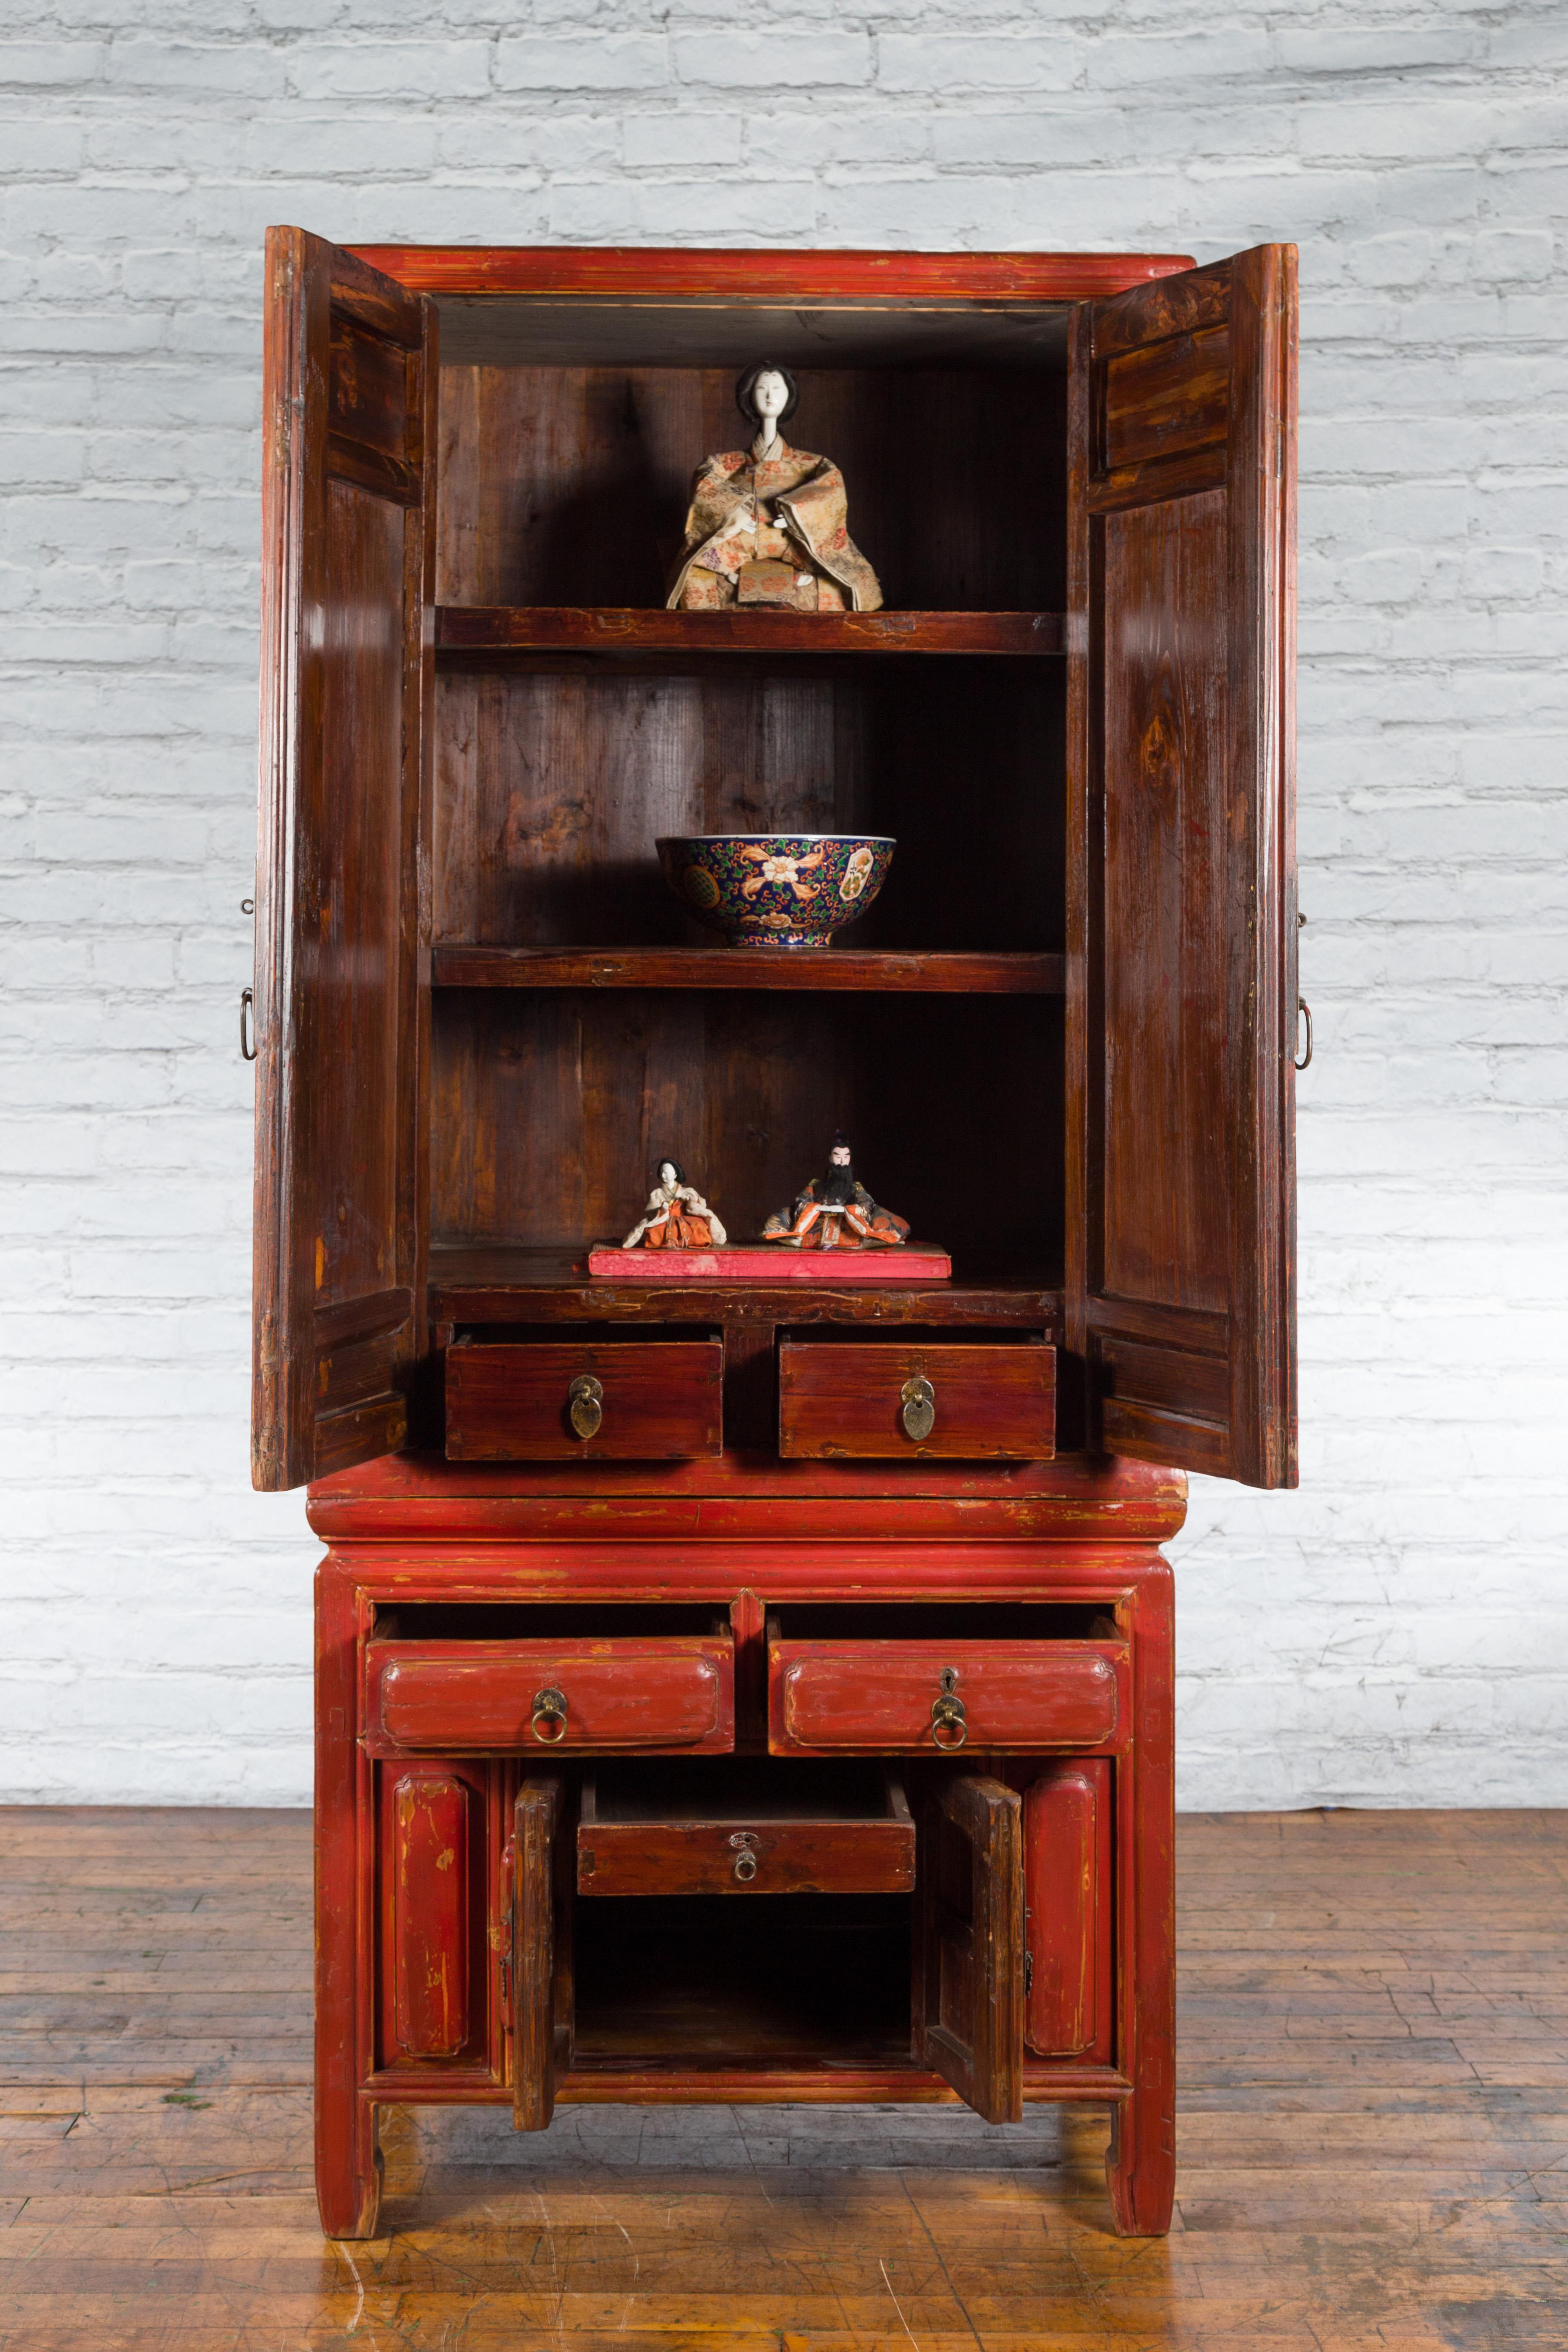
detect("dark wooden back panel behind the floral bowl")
[435,649,1065,952]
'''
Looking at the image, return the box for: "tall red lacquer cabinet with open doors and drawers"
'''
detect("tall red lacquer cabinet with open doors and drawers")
[254,230,1298,2237]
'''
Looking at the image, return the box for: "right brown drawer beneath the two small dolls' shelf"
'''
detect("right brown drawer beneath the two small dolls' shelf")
[778,1341,1056,1463]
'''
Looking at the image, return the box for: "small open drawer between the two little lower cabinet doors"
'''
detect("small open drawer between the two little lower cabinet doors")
[576,1757,915,1896]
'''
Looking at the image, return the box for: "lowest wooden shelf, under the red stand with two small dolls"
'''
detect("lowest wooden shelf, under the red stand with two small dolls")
[430,1242,1063,1329]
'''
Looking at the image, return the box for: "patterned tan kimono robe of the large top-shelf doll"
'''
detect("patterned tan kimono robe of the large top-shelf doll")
[668,440,882,612]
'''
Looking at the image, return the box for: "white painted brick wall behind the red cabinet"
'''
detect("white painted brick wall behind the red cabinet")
[0,0,1568,1806]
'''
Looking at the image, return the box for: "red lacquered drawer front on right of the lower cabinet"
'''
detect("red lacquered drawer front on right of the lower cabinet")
[769,1642,1126,1755]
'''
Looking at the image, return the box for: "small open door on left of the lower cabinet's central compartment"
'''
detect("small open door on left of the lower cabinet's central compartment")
[505,1773,571,2131]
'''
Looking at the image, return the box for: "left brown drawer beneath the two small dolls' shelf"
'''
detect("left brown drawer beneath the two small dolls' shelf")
[447,1338,724,1463]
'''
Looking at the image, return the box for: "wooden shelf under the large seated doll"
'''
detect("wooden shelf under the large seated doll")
[435,604,1067,666]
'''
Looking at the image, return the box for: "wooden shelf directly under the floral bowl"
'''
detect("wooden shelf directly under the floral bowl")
[430,941,1063,997]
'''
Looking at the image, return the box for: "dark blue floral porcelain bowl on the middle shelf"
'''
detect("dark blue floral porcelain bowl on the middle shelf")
[656,833,898,948]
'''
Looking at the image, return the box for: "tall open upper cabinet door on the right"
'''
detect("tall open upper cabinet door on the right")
[1067,245,1295,1486]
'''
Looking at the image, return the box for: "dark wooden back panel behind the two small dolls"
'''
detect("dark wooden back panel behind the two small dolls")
[432,988,1060,1279]
